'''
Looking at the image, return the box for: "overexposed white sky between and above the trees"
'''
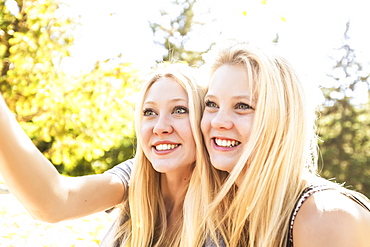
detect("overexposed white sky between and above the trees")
[59,0,370,102]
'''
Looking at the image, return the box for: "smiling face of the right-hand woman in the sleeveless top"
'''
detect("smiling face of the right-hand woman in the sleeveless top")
[201,64,255,172]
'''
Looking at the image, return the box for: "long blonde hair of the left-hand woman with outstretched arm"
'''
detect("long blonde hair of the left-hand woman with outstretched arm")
[112,63,204,247]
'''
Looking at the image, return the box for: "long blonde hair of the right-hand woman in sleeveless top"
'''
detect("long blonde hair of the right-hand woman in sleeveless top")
[188,43,316,247]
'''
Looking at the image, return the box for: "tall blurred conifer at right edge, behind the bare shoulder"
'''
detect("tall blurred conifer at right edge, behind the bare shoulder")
[318,22,370,196]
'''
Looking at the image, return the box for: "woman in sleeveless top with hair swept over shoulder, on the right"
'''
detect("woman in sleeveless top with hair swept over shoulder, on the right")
[185,43,370,247]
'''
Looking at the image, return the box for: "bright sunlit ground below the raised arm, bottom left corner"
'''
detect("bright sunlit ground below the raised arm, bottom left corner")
[0,178,116,247]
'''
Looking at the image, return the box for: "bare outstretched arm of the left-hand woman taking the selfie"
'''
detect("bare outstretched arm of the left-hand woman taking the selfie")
[0,94,125,222]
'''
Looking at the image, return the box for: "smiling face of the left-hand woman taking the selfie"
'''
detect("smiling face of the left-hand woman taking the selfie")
[140,77,195,173]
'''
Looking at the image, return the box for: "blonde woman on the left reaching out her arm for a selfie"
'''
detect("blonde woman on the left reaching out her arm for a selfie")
[0,64,205,247]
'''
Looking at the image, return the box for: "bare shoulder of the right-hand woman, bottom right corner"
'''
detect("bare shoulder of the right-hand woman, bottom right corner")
[293,190,370,247]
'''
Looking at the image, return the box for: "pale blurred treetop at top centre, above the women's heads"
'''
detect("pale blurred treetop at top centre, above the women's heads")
[150,0,213,66]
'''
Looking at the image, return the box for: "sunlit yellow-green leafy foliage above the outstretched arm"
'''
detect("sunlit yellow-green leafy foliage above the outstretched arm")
[0,0,138,175]
